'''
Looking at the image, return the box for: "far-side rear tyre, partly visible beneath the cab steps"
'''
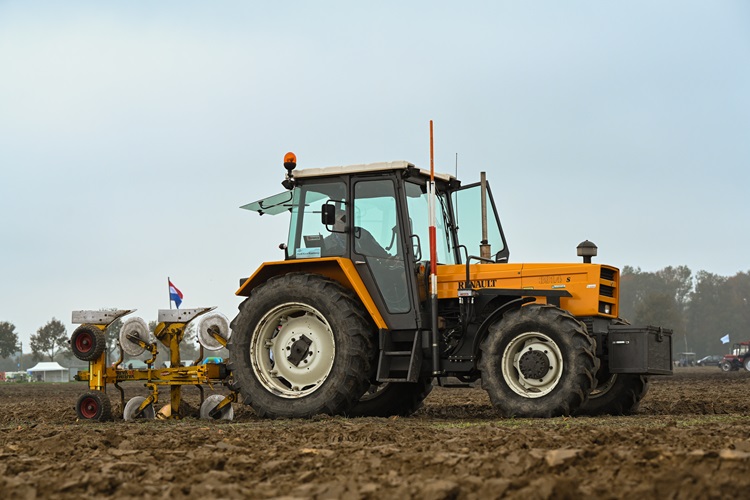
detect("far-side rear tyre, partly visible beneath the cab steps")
[349,377,432,417]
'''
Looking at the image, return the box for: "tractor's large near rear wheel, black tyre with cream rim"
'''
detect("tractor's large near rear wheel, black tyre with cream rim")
[228,273,375,418]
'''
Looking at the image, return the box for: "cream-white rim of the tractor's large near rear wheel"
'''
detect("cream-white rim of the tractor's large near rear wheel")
[250,302,336,399]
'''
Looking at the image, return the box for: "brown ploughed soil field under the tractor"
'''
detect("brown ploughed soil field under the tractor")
[0,367,750,500]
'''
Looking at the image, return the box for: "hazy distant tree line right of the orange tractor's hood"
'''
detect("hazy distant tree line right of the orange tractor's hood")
[620,266,750,359]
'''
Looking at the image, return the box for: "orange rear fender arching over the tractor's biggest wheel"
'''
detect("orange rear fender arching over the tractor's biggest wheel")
[235,257,388,329]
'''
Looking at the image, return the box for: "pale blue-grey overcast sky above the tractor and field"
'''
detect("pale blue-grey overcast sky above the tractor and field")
[0,0,750,351]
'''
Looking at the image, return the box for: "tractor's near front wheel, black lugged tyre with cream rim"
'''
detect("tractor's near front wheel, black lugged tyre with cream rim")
[478,305,599,418]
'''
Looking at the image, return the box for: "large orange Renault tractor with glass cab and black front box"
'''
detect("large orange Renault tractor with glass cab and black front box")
[228,153,672,418]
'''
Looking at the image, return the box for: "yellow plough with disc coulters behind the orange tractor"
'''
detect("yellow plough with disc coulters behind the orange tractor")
[70,307,237,421]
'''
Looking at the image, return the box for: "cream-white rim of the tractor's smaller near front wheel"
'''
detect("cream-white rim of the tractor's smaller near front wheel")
[502,332,563,399]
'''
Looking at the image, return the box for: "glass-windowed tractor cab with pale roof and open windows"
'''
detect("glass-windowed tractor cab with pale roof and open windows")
[242,161,509,330]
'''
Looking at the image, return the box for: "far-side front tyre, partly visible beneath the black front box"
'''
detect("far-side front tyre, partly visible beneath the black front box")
[576,373,648,416]
